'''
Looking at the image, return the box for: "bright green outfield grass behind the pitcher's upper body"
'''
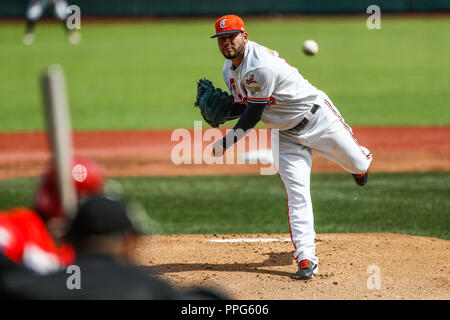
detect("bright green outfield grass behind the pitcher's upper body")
[0,17,450,131]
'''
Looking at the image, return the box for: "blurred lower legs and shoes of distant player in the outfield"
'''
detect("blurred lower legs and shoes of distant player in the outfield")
[23,0,81,45]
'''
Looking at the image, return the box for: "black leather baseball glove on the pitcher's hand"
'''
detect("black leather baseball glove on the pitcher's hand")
[194,79,234,128]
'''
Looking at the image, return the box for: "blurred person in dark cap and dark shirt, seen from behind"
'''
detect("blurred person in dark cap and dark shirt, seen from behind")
[3,195,182,300]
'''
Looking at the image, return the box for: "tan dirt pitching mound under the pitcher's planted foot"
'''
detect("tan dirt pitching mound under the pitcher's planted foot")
[135,234,450,300]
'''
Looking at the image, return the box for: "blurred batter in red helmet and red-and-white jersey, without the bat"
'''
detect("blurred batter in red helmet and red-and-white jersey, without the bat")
[0,158,104,276]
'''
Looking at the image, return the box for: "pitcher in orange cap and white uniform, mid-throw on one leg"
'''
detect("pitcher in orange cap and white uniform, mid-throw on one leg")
[195,15,373,279]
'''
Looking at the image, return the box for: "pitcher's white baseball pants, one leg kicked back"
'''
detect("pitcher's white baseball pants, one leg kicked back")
[271,92,373,263]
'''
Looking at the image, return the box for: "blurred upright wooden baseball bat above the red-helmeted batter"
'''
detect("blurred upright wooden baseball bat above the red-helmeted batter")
[41,65,77,219]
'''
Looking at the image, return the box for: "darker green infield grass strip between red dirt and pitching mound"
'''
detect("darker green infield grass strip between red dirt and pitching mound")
[0,172,450,240]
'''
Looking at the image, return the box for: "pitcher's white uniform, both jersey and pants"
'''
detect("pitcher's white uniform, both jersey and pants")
[223,41,372,263]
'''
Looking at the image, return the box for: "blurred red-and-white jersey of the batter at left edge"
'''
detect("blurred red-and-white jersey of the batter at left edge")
[0,208,75,274]
